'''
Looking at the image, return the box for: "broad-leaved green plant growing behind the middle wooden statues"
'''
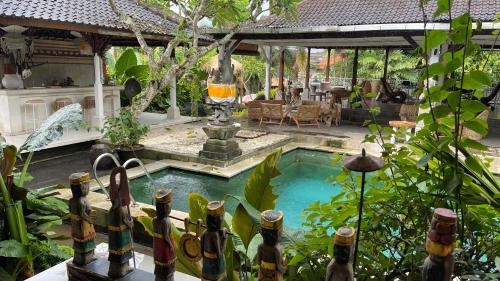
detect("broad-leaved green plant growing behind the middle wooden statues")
[137,150,282,280]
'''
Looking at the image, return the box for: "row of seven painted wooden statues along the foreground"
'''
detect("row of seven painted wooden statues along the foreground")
[68,167,457,281]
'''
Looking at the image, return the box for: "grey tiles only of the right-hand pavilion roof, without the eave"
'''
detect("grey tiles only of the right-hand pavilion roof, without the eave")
[253,0,500,30]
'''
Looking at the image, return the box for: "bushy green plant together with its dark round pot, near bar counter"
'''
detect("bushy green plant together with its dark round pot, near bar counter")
[101,109,149,163]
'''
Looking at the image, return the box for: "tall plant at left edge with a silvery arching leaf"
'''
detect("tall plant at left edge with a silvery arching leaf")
[0,104,82,280]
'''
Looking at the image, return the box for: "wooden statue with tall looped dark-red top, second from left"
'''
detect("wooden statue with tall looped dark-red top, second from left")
[108,167,134,278]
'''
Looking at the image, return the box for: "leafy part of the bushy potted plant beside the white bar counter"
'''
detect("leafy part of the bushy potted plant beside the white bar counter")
[99,108,149,148]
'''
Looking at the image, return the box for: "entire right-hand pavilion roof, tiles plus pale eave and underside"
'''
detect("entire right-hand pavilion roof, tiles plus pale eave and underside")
[217,0,500,49]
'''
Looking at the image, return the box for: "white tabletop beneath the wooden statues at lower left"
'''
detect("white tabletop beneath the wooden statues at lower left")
[26,243,200,281]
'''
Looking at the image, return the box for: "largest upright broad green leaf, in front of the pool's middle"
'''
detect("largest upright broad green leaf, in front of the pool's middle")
[233,150,282,248]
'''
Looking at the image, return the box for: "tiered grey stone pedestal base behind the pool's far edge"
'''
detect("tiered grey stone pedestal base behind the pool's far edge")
[199,124,241,161]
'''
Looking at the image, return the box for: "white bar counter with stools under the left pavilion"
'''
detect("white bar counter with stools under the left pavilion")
[0,86,123,135]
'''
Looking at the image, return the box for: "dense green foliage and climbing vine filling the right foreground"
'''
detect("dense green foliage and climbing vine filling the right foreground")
[289,0,500,280]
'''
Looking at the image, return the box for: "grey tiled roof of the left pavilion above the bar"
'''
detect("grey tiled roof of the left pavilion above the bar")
[0,0,177,35]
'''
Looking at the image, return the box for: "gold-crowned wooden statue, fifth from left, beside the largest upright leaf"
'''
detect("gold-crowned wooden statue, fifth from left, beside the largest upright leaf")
[254,210,286,281]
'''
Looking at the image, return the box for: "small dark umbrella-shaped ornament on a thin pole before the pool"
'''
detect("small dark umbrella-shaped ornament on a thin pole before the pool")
[344,148,384,268]
